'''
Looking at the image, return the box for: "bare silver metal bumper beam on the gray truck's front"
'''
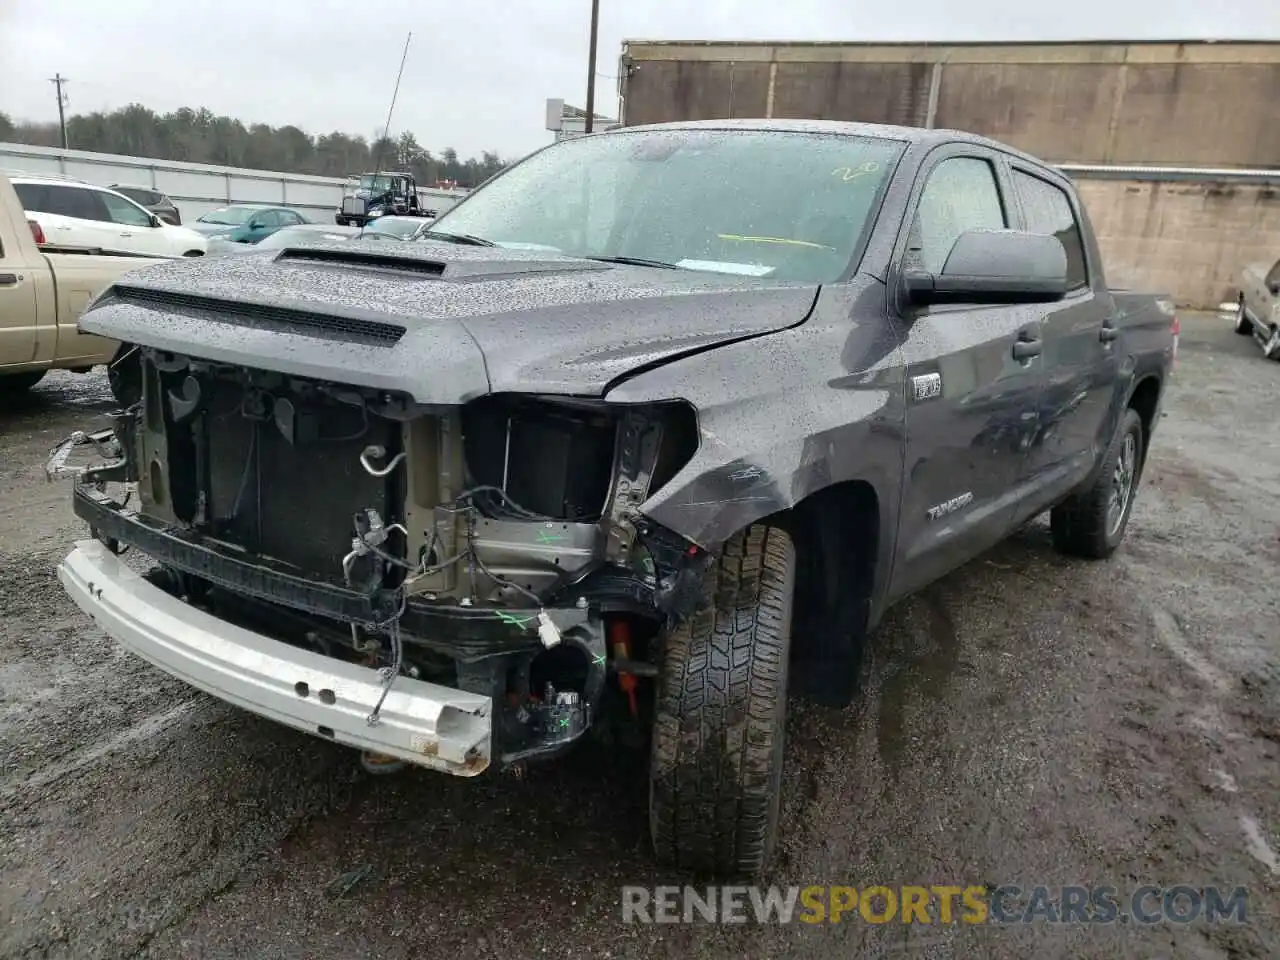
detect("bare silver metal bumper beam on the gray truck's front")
[58,540,493,777]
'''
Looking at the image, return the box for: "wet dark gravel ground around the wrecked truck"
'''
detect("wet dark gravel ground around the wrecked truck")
[0,316,1280,960]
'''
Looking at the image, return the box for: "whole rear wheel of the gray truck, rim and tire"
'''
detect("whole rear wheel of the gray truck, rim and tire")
[1050,407,1144,559]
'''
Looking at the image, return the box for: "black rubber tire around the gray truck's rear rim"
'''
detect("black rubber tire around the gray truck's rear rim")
[1050,407,1146,559]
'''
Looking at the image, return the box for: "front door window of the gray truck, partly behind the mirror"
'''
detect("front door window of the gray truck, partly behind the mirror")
[911,156,1009,274]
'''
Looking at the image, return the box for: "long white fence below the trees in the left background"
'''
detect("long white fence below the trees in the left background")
[0,143,467,223]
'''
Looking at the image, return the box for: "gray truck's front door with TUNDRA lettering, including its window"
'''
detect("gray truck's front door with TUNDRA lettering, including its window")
[890,145,1042,596]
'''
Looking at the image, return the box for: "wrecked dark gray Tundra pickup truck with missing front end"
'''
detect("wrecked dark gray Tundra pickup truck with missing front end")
[51,122,1176,876]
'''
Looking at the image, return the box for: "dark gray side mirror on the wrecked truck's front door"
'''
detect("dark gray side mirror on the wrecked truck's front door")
[904,230,1066,305]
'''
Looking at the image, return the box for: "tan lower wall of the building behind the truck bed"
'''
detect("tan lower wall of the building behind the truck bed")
[1075,180,1280,310]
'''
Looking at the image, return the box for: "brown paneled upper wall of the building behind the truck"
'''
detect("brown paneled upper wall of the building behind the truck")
[620,41,1280,168]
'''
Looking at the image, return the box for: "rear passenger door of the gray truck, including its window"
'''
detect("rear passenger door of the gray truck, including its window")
[1010,160,1120,521]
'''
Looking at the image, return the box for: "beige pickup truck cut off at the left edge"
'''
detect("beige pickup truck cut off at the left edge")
[0,174,161,406]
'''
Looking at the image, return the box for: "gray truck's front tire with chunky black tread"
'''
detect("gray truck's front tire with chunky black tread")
[649,524,796,877]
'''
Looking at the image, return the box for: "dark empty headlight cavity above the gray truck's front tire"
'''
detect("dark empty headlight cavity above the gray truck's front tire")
[462,396,698,524]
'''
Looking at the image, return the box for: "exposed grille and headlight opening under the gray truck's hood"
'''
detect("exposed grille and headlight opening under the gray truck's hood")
[131,358,698,602]
